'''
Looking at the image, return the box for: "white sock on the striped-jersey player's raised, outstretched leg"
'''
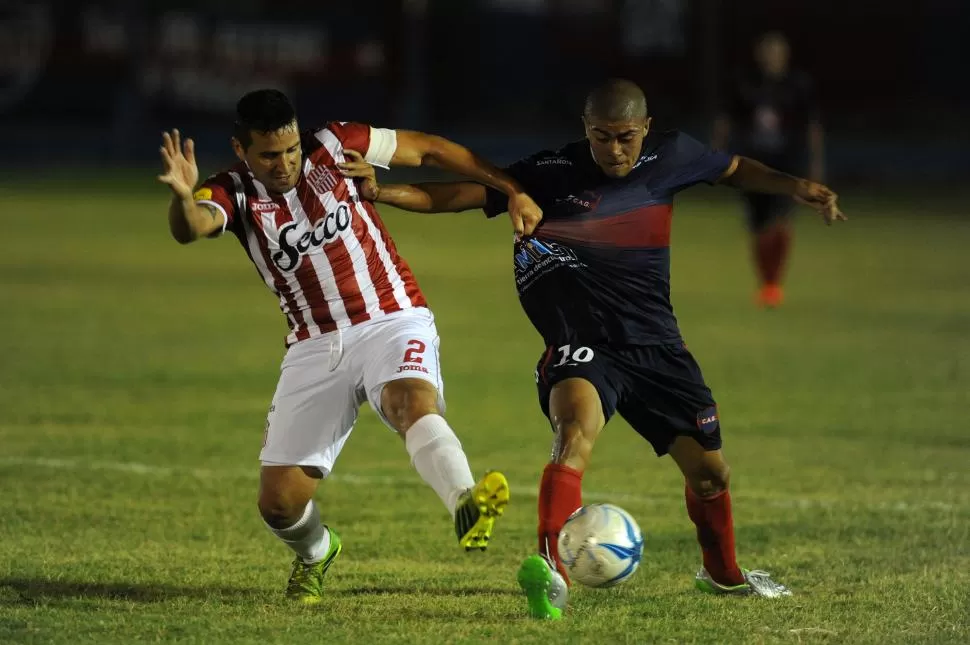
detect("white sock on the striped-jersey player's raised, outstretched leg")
[404,414,475,516]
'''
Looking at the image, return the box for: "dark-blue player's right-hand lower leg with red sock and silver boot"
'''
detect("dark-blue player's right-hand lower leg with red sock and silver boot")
[670,436,791,598]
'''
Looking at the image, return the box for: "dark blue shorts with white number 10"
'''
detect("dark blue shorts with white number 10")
[536,343,721,456]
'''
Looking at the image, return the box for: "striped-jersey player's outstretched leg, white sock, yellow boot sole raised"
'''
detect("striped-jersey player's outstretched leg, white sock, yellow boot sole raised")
[381,379,509,551]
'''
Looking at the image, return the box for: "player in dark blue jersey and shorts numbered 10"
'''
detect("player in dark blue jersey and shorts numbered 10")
[343,80,844,618]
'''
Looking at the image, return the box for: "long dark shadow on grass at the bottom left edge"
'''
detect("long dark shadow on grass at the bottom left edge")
[0,578,264,606]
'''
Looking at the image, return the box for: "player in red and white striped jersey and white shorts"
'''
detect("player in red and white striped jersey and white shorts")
[158,90,541,604]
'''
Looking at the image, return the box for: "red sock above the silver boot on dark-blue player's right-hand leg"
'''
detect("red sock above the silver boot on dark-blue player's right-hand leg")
[685,486,744,585]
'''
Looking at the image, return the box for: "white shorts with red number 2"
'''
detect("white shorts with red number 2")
[259,307,444,477]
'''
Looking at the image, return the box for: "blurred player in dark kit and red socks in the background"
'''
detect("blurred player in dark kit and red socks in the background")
[711,32,825,308]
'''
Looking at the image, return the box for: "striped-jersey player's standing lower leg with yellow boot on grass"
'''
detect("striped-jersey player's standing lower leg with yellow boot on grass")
[258,465,341,605]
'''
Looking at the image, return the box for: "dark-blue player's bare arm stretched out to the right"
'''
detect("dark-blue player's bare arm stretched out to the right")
[718,155,846,224]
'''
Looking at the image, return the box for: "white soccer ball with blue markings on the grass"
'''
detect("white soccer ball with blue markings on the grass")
[559,504,643,587]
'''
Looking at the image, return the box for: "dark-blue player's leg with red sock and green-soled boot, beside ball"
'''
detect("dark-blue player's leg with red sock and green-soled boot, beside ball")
[518,378,606,619]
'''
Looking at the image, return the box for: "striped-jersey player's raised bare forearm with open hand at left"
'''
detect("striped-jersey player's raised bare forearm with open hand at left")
[158,130,226,244]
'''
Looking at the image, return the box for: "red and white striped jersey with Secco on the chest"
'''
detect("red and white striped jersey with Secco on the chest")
[195,122,427,346]
